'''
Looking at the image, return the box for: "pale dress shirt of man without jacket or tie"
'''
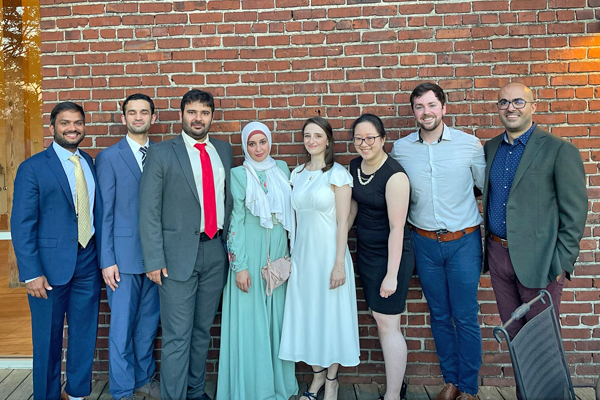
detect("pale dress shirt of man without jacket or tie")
[391,124,486,232]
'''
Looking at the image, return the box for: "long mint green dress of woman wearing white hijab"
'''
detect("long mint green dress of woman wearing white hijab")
[217,161,298,400]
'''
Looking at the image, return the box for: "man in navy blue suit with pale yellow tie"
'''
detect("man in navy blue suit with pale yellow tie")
[10,102,102,400]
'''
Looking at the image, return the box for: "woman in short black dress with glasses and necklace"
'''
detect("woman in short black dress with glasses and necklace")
[349,114,414,400]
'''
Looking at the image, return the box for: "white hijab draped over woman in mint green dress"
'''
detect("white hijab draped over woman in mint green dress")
[242,122,296,252]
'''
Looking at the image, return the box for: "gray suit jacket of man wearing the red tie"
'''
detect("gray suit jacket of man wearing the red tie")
[140,133,233,281]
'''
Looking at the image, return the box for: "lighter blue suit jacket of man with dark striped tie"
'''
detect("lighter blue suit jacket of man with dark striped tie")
[96,138,153,274]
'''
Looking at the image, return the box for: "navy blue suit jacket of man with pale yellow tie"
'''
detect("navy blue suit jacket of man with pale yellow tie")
[10,146,102,285]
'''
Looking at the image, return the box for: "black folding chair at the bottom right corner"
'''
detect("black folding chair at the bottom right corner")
[494,290,576,400]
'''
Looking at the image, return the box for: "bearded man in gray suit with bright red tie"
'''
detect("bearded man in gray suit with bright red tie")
[140,90,233,400]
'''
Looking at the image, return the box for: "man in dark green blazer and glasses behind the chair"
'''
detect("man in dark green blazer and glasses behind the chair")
[483,83,588,338]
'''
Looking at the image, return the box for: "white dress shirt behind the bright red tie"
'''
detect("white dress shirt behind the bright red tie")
[181,132,225,232]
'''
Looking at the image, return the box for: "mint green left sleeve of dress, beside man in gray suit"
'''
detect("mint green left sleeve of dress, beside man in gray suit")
[227,167,248,272]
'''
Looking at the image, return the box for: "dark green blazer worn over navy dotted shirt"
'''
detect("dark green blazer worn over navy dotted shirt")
[483,127,588,288]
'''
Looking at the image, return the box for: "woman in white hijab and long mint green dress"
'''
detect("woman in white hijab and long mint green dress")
[217,122,298,400]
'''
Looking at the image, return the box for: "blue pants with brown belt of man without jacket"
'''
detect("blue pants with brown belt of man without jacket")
[411,230,482,395]
